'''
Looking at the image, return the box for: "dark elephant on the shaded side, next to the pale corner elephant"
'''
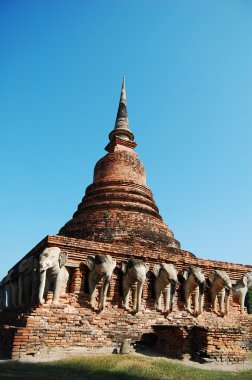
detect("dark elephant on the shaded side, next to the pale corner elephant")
[18,256,38,306]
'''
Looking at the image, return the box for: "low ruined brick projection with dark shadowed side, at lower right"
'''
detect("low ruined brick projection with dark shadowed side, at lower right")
[153,324,252,363]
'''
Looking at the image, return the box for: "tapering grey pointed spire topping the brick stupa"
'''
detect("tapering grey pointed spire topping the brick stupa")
[109,77,134,141]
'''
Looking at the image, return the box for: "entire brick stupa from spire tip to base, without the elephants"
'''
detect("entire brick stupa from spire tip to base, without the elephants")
[0,81,252,363]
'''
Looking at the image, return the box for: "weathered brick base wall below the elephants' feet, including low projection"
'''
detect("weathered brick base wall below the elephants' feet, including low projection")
[0,293,252,362]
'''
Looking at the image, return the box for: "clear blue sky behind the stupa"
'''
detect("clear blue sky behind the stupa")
[0,0,252,277]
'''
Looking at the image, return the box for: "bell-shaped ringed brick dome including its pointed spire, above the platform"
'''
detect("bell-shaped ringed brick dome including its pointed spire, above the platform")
[59,78,180,248]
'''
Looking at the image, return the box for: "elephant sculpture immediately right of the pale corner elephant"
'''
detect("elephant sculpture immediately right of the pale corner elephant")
[86,254,116,310]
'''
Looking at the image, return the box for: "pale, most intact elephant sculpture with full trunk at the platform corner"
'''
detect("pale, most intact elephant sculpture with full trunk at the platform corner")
[38,247,69,305]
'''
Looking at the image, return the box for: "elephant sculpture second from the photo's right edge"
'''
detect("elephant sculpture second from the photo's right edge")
[208,269,232,314]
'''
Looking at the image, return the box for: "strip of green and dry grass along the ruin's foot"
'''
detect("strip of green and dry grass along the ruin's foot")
[0,355,252,380]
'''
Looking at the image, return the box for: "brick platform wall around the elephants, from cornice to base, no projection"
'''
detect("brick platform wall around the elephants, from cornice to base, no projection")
[0,235,252,360]
